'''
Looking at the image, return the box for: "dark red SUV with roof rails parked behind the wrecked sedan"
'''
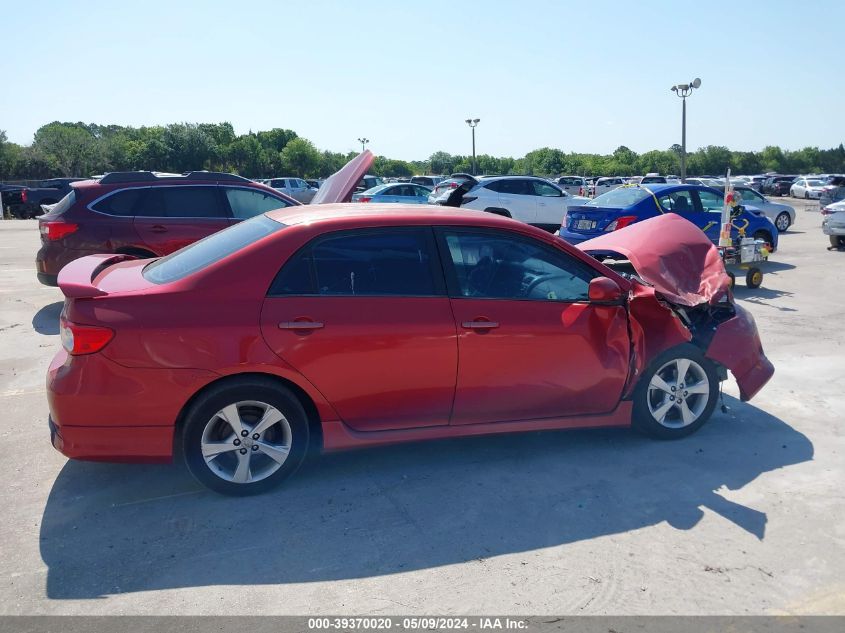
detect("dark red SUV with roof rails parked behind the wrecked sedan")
[35,171,300,286]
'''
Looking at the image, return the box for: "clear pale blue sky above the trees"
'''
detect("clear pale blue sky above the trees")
[0,0,845,159]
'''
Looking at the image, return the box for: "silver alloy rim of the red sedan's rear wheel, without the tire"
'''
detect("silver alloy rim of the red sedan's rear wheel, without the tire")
[200,400,293,484]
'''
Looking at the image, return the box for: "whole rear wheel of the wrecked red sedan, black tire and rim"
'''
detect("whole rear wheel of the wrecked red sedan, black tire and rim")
[182,377,310,496]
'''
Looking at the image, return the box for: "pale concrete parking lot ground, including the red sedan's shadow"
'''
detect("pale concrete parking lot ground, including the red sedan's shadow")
[0,201,845,615]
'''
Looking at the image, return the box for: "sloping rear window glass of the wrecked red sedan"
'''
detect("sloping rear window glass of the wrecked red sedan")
[143,215,285,284]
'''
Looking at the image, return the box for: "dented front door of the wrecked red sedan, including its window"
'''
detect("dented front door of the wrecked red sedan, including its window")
[438,229,630,424]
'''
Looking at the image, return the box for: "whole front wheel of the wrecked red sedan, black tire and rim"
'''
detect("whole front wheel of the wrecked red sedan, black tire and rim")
[632,343,719,440]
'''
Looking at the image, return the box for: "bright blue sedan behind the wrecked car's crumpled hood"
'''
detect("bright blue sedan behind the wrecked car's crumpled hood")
[558,184,778,250]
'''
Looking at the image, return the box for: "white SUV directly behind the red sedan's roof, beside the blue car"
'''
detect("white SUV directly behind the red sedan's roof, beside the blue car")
[434,176,589,232]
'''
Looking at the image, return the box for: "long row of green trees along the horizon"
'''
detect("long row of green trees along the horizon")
[0,121,845,181]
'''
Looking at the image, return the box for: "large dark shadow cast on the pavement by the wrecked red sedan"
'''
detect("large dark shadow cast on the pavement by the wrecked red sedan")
[40,397,813,599]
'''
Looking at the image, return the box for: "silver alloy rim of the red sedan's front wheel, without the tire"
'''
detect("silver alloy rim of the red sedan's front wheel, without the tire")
[646,358,710,429]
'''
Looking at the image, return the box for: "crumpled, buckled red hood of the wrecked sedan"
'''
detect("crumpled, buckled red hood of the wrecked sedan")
[577,213,730,306]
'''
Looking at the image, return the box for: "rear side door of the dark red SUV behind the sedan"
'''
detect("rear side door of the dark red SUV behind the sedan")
[135,185,230,255]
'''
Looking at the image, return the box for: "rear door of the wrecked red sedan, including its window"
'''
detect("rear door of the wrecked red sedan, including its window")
[261,227,458,431]
